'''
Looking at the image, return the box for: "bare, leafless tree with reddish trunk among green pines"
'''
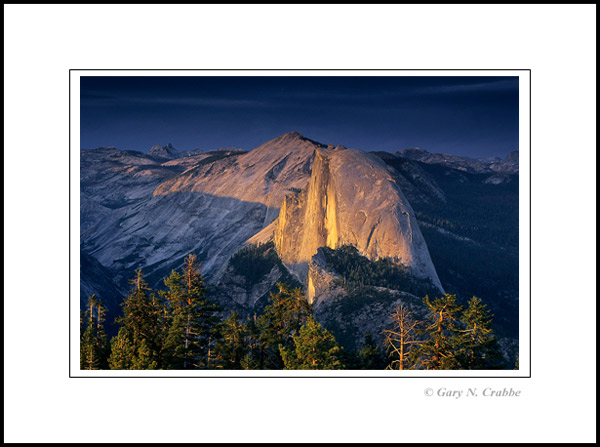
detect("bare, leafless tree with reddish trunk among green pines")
[384,304,420,370]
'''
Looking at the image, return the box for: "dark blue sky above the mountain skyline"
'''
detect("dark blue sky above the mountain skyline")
[80,76,519,158]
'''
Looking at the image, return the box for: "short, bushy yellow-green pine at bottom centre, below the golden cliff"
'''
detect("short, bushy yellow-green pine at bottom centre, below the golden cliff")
[279,315,343,370]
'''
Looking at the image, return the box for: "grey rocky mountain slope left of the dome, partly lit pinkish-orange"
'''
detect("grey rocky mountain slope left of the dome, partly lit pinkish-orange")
[81,133,319,290]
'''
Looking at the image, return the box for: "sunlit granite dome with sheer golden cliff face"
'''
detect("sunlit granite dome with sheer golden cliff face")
[274,148,442,298]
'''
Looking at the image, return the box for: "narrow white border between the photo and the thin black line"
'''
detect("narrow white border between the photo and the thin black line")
[69,69,531,378]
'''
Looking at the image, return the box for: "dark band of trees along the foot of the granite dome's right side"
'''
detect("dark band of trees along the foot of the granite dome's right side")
[322,245,437,296]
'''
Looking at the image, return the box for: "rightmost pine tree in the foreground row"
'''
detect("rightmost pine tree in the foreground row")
[458,297,503,369]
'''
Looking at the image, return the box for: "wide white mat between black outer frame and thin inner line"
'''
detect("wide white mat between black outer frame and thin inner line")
[4,5,596,442]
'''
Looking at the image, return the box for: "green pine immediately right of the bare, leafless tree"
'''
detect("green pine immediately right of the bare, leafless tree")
[418,293,463,370]
